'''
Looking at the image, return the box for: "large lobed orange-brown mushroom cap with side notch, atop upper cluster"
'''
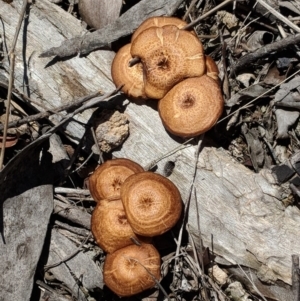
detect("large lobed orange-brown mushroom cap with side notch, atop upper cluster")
[131,25,206,99]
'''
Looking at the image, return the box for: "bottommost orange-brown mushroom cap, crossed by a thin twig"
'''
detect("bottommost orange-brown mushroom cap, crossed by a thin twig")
[103,244,160,297]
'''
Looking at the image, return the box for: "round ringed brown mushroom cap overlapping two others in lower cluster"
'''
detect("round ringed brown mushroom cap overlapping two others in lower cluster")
[121,172,182,237]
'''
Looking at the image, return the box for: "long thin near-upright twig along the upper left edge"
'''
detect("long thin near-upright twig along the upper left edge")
[0,0,30,171]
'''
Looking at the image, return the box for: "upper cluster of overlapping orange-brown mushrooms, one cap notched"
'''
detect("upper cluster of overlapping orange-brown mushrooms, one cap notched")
[111,17,224,137]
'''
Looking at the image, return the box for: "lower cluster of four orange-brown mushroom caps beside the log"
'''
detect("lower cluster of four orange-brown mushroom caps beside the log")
[89,159,182,297]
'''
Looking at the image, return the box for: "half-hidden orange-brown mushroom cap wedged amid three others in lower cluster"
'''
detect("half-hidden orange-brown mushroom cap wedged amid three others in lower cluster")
[91,199,150,253]
